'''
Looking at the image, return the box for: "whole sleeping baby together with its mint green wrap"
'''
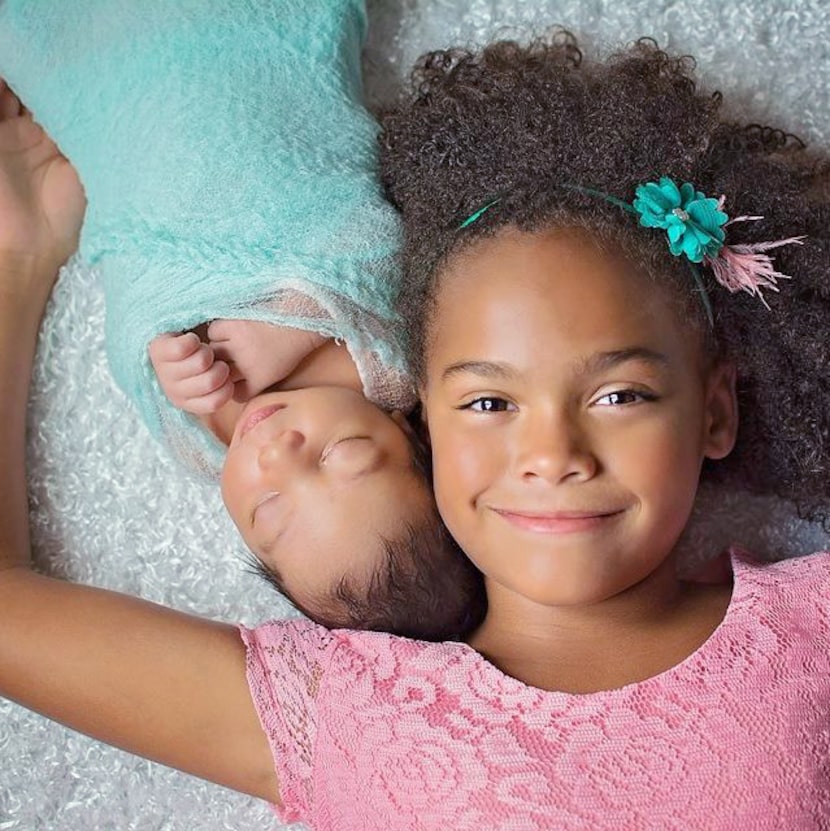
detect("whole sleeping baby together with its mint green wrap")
[0,0,483,638]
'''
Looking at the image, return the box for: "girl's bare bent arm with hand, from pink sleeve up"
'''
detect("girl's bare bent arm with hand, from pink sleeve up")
[0,89,279,802]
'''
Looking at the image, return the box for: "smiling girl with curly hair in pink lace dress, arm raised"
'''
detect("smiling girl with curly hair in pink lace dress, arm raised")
[0,36,830,829]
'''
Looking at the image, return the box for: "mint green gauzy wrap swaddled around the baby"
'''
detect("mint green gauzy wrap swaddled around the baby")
[0,0,412,471]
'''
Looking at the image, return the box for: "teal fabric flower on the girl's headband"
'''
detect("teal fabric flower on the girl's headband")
[632,176,729,263]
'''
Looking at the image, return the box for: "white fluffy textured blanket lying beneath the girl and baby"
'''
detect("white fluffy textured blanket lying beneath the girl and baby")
[0,0,830,831]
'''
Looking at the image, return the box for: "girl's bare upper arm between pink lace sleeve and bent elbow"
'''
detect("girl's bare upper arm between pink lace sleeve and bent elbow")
[0,580,279,802]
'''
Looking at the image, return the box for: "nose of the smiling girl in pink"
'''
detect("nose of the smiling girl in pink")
[515,414,598,483]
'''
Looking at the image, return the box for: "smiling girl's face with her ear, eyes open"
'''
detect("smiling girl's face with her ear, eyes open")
[422,229,737,605]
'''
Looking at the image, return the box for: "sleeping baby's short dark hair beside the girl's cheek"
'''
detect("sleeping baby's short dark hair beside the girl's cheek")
[250,440,487,641]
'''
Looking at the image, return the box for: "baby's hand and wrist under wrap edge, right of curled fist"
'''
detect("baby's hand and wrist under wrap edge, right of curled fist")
[207,320,326,402]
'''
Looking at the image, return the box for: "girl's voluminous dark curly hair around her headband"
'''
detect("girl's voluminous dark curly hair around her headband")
[381,30,830,524]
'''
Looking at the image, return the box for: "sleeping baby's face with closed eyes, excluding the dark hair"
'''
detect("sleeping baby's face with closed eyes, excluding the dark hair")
[222,387,432,605]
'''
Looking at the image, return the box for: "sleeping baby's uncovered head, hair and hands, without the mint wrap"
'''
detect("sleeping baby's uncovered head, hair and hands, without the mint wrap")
[150,320,483,639]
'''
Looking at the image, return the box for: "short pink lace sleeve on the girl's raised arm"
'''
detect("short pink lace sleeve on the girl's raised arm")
[239,620,334,822]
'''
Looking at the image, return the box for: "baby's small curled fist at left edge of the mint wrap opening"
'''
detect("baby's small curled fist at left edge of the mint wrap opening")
[150,332,233,416]
